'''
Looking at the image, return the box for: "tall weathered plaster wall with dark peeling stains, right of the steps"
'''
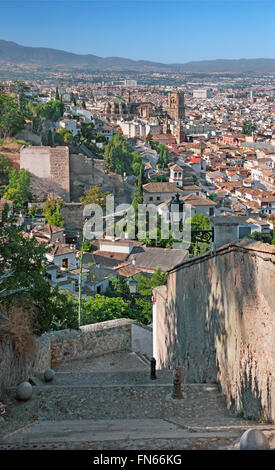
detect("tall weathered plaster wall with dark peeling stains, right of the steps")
[154,240,275,421]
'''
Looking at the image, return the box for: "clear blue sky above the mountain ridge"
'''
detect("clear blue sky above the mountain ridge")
[0,0,275,63]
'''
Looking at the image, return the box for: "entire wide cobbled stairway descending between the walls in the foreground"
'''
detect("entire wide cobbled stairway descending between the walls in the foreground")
[0,353,274,450]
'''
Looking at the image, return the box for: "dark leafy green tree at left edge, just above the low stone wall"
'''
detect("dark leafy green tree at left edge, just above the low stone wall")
[0,218,77,335]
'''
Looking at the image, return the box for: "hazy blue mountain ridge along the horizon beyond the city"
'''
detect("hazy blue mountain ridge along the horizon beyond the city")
[0,40,275,73]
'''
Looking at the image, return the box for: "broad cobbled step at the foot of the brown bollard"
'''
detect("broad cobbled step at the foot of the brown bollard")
[5,381,230,425]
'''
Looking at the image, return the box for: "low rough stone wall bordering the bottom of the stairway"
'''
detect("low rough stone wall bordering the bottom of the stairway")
[0,319,142,393]
